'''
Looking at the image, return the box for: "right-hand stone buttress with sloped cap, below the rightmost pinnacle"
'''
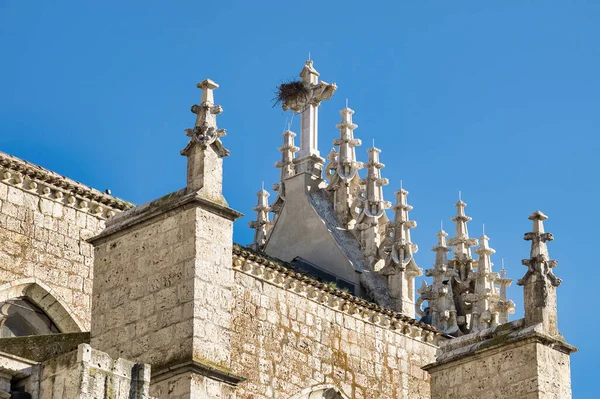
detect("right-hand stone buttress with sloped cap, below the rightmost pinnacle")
[425,319,576,399]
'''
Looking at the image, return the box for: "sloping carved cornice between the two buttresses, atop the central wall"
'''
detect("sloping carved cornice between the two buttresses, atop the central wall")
[232,244,451,345]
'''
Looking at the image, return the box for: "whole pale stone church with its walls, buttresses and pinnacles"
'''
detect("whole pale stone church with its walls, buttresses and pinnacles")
[0,61,576,399]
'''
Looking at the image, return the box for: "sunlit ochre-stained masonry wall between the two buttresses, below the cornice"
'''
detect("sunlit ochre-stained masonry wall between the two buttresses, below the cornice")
[231,262,436,399]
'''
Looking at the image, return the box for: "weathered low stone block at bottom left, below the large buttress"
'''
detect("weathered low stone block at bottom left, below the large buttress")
[39,344,150,399]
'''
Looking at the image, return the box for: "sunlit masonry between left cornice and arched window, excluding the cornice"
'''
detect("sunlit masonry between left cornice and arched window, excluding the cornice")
[0,176,112,332]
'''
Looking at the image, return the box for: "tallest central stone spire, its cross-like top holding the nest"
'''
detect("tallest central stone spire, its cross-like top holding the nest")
[282,60,337,178]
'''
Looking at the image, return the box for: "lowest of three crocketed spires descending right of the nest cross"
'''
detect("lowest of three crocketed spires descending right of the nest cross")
[380,185,422,317]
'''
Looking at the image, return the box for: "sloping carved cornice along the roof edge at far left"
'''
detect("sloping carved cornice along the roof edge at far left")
[0,152,134,218]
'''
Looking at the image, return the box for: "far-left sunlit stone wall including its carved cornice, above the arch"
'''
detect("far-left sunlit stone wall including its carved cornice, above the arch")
[0,153,130,332]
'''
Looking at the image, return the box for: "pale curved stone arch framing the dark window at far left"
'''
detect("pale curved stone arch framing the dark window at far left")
[0,278,84,333]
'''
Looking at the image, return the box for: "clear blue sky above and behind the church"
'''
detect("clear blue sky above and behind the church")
[0,0,600,398]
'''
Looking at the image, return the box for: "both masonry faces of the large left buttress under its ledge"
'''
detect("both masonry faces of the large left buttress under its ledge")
[91,195,234,380]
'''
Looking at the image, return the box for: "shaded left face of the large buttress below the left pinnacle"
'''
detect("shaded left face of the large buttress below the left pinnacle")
[91,208,199,367]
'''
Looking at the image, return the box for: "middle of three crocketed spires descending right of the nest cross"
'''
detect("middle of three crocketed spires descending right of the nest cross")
[356,145,391,270]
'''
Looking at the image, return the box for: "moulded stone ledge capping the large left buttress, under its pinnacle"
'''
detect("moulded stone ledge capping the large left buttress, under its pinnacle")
[88,188,243,244]
